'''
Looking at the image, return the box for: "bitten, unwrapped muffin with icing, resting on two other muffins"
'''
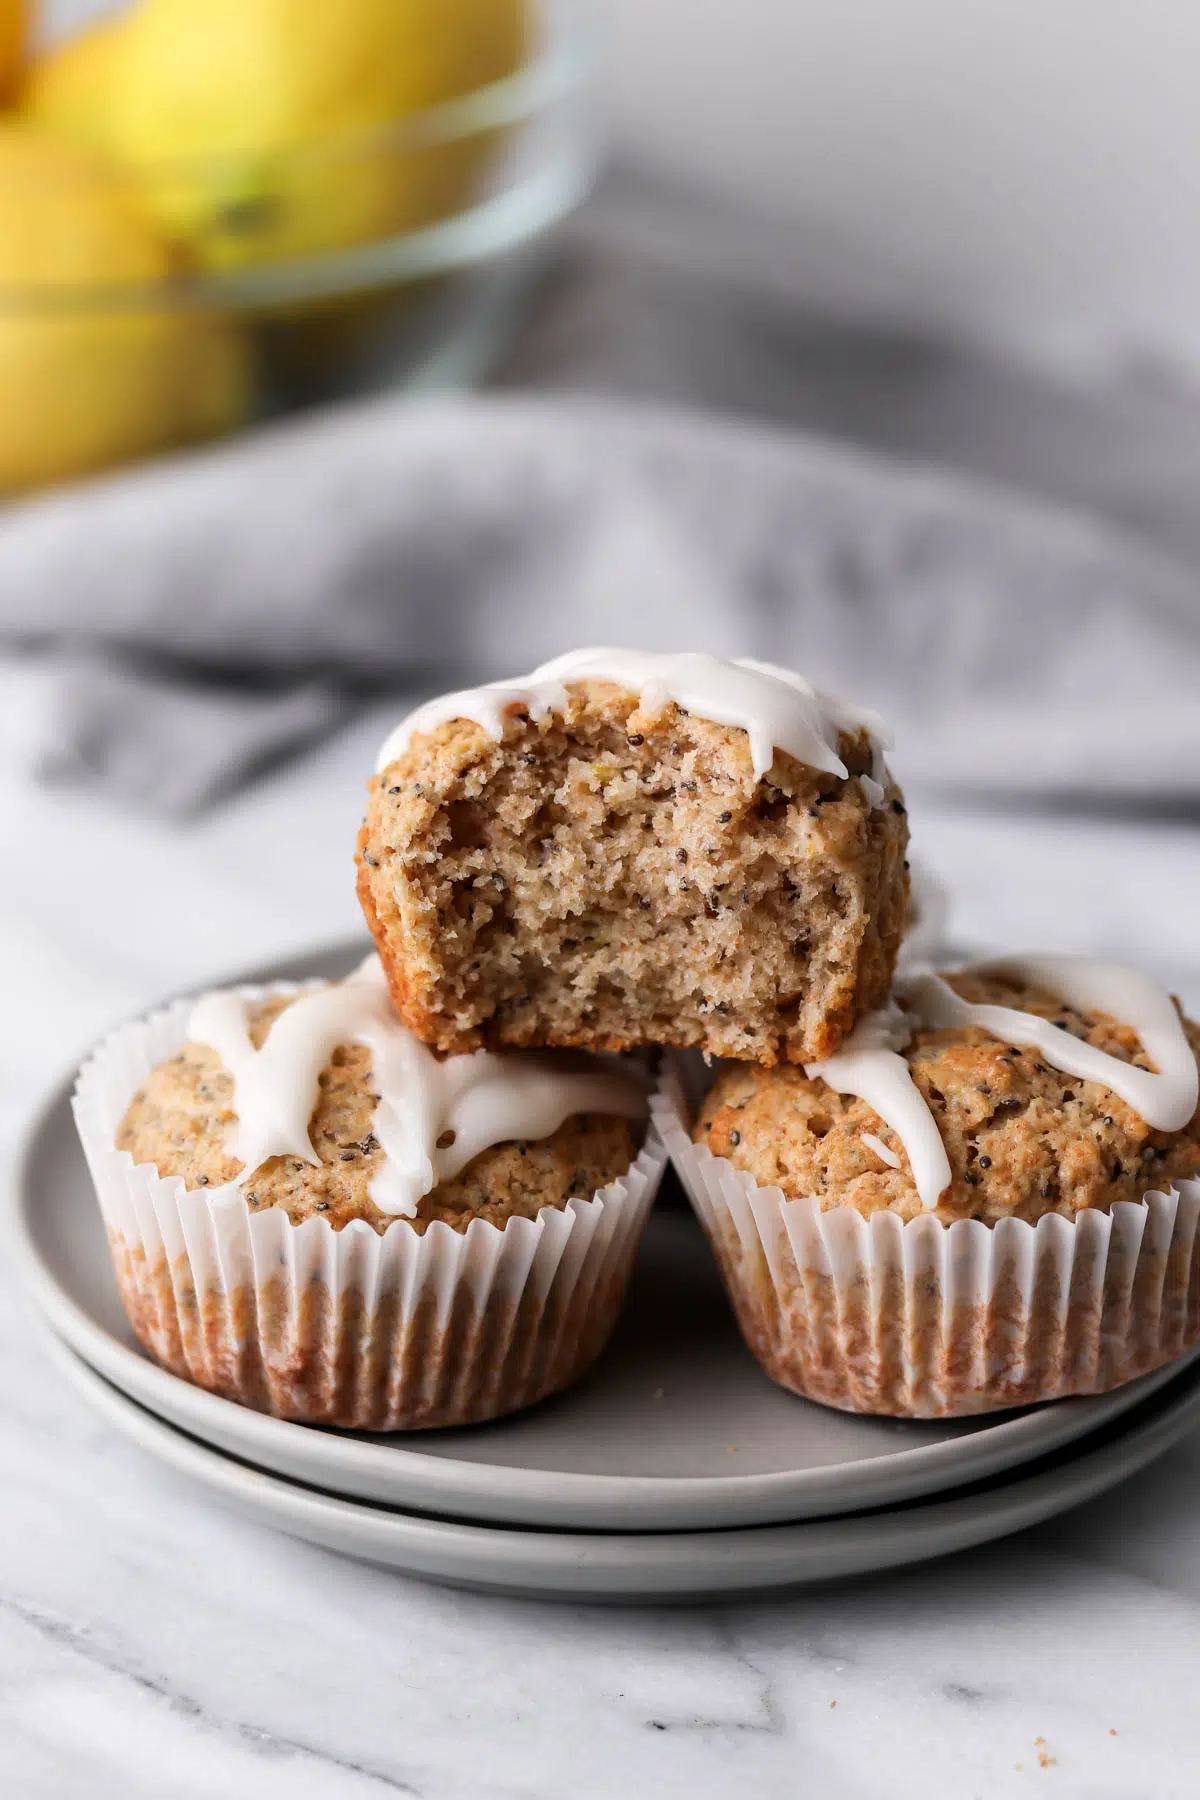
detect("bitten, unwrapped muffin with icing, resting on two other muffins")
[358,652,909,1066]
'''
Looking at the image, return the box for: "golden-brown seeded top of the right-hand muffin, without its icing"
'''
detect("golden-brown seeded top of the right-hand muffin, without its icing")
[693,967,1200,1224]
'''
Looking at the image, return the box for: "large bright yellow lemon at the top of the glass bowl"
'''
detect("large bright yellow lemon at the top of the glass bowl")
[112,0,529,268]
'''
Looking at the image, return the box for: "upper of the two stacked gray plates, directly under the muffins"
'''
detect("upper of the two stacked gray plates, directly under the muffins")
[16,947,1200,1530]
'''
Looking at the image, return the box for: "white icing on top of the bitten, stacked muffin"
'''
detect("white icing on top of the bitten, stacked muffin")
[378,650,891,788]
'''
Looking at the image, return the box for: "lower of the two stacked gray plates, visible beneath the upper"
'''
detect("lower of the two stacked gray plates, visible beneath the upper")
[47,1334,1200,1600]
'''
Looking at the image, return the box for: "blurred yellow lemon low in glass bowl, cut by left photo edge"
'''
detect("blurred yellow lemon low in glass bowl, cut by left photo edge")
[0,124,250,491]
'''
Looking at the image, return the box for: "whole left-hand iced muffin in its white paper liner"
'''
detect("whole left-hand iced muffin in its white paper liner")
[76,958,666,1431]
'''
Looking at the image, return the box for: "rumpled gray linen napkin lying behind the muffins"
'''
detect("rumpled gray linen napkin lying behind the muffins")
[0,400,1200,814]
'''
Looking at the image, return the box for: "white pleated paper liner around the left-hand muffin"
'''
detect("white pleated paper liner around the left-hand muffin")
[74,983,666,1431]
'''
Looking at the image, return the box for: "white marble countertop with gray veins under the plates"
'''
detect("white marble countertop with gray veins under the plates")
[0,698,1200,1800]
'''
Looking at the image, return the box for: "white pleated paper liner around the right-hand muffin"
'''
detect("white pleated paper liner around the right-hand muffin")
[655,1073,1200,1418]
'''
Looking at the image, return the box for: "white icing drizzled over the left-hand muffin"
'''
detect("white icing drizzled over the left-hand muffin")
[187,956,648,1217]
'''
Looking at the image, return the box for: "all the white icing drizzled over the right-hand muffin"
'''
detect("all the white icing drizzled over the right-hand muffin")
[804,956,1200,1208]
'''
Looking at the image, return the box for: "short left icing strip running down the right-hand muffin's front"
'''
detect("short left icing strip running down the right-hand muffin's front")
[804,1006,950,1206]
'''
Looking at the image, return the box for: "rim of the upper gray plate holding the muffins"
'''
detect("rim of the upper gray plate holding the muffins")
[14,938,1200,1530]
